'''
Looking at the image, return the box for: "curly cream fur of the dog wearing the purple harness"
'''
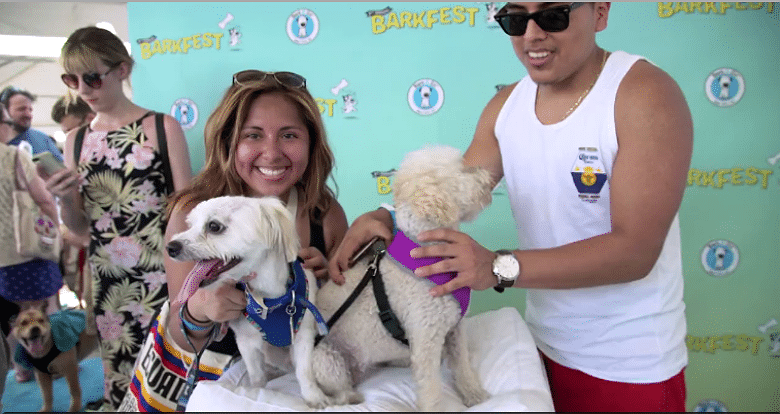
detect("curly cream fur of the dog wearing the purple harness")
[314,146,491,411]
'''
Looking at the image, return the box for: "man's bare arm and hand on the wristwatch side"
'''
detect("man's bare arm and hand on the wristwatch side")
[412,61,693,295]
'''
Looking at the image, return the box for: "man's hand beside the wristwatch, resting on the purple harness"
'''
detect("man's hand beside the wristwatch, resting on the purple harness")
[410,229,497,296]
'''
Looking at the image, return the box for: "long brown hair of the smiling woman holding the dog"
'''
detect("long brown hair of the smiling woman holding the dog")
[168,76,335,223]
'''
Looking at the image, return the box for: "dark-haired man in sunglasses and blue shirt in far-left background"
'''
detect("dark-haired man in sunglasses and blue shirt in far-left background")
[0,86,62,161]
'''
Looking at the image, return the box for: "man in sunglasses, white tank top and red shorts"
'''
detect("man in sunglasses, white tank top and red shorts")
[329,3,693,411]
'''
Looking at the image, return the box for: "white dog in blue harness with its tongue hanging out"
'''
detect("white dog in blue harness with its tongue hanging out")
[167,196,331,407]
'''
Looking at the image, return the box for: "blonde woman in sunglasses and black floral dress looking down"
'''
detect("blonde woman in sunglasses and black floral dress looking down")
[47,27,192,409]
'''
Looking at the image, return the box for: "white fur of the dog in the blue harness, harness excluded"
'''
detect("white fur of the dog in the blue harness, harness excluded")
[169,196,331,407]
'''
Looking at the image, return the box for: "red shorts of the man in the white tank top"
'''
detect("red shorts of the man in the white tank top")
[539,352,685,412]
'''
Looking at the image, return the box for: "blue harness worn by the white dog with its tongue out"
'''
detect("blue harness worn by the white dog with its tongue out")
[238,258,328,347]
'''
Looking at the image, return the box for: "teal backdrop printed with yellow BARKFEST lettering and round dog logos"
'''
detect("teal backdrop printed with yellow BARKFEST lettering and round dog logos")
[128,2,780,411]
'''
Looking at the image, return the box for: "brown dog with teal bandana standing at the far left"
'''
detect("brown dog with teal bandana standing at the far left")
[11,307,98,412]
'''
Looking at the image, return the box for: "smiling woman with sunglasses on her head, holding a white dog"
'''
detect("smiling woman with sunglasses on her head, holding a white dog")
[116,70,347,410]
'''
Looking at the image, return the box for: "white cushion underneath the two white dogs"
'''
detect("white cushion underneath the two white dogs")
[187,307,554,412]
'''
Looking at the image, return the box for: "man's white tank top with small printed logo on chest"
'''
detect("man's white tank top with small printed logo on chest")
[495,51,688,383]
